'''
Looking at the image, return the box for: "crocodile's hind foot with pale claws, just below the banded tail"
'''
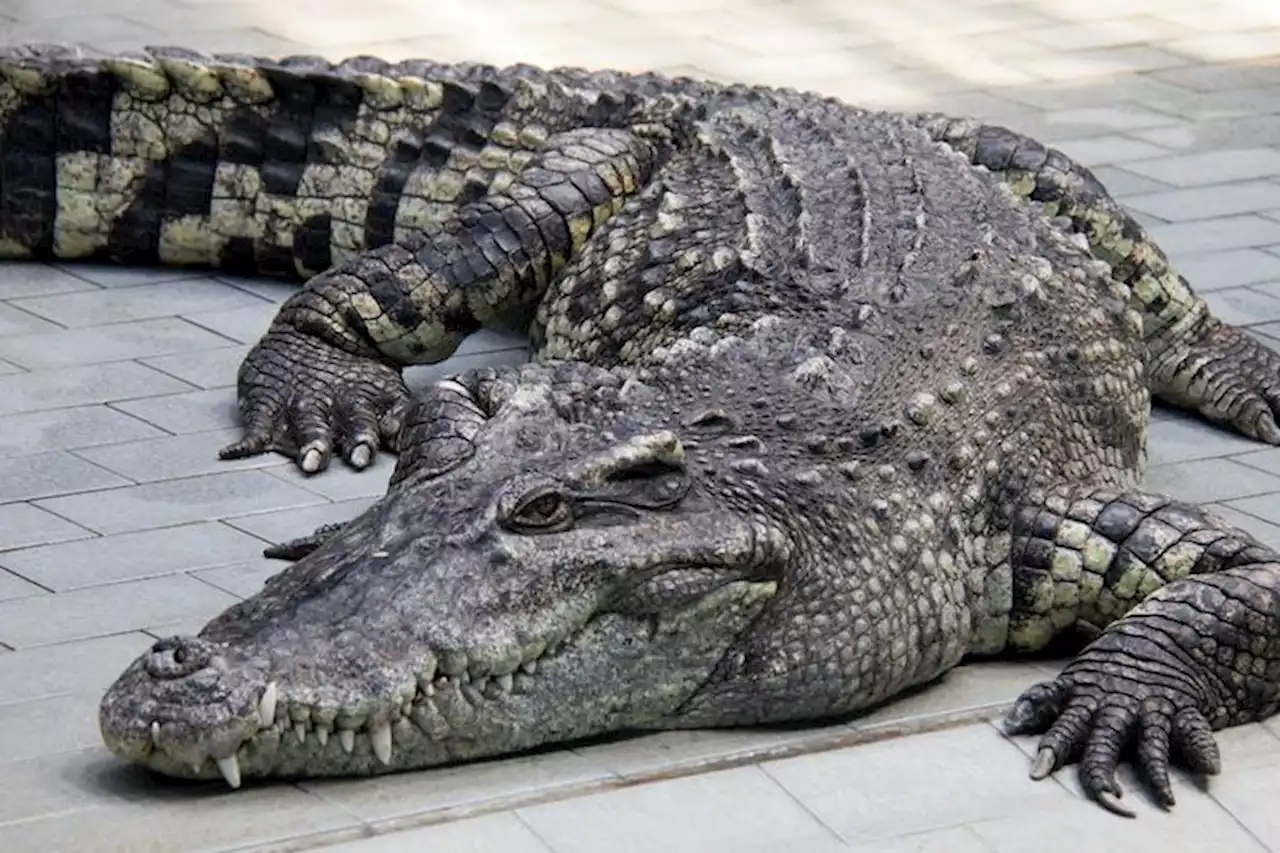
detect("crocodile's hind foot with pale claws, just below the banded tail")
[219,327,408,474]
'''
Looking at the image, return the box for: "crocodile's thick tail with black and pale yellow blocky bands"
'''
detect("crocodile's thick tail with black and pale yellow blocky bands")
[0,45,660,278]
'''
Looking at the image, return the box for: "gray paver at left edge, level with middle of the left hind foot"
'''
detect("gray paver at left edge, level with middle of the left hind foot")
[0,361,189,415]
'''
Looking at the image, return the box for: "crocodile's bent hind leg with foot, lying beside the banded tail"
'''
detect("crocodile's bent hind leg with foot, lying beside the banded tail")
[221,128,659,474]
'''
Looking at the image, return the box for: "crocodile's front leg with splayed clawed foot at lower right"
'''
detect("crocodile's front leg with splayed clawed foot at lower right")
[1005,488,1280,816]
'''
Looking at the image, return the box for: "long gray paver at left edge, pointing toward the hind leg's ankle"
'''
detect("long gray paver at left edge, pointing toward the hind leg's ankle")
[0,318,235,370]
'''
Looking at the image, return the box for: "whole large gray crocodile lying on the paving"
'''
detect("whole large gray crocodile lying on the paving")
[0,46,1280,815]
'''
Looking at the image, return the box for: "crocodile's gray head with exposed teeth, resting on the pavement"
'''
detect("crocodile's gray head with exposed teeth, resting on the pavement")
[100,366,787,785]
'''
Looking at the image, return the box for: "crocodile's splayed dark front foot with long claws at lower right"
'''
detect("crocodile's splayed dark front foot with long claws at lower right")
[1005,634,1221,817]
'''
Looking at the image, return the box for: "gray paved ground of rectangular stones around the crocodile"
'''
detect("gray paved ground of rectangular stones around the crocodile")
[0,0,1280,853]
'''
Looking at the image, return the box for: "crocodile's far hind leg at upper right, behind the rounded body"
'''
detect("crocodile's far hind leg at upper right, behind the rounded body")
[920,115,1280,444]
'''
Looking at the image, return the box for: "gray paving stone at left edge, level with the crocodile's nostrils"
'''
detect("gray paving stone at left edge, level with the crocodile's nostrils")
[0,631,155,706]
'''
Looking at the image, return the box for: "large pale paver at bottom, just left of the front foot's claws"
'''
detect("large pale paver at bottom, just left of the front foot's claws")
[762,725,1070,844]
